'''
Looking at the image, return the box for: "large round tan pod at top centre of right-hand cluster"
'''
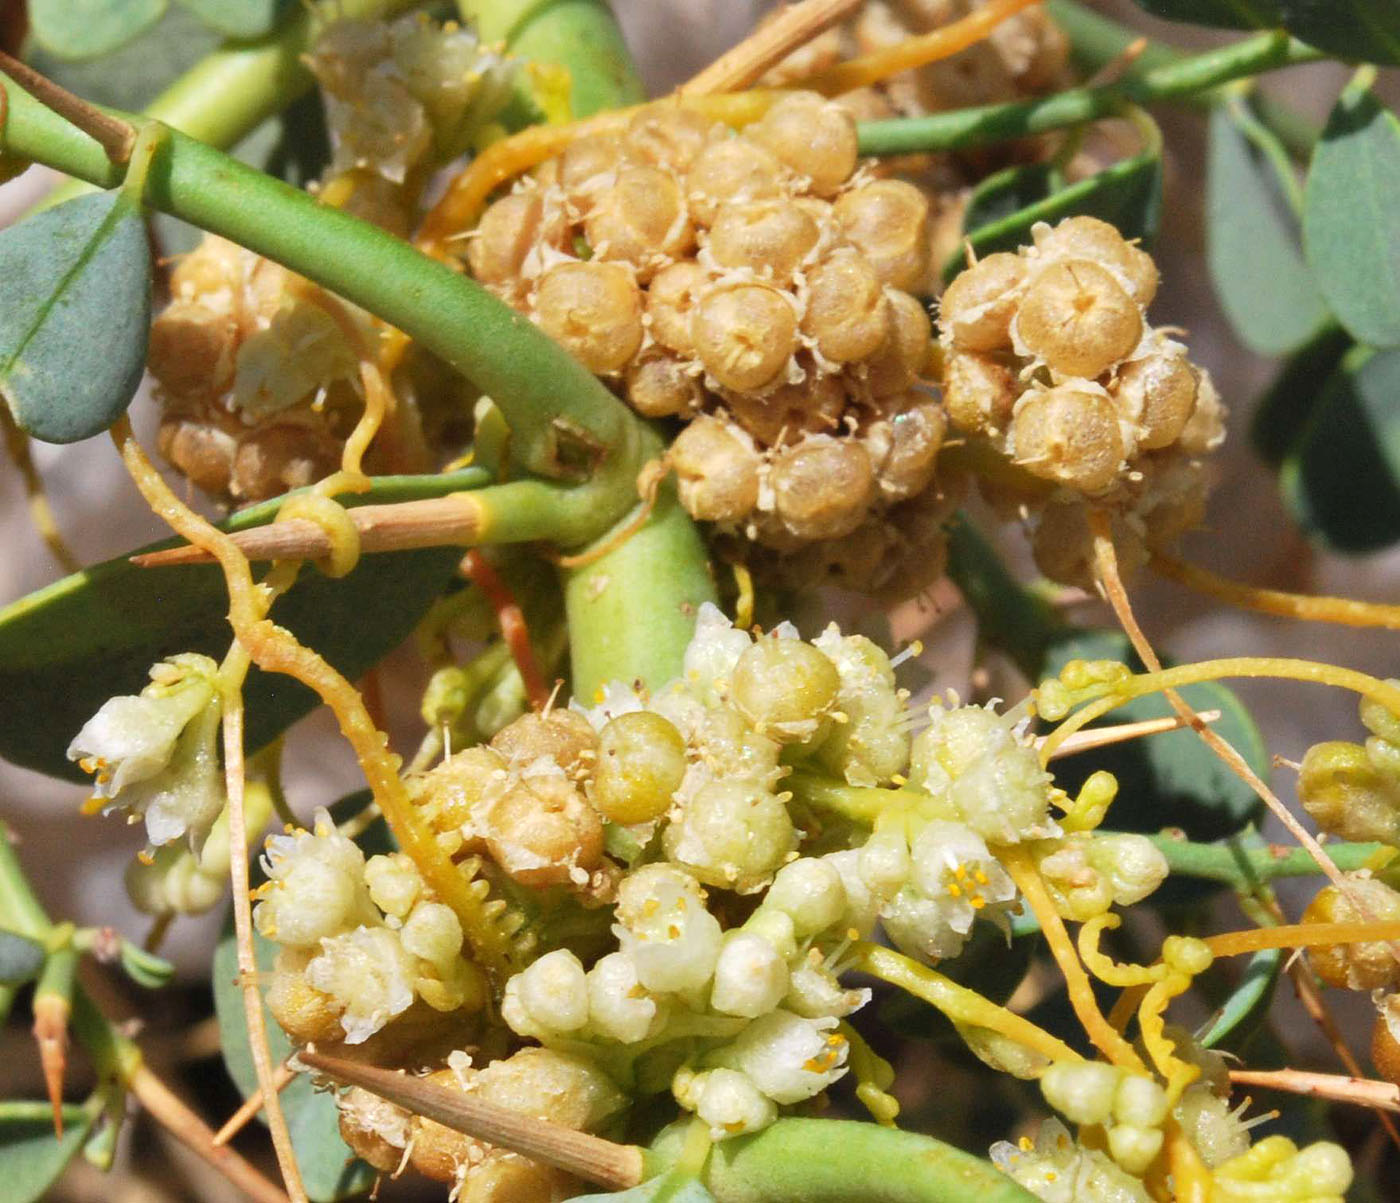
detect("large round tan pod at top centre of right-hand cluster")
[1015,259,1142,378]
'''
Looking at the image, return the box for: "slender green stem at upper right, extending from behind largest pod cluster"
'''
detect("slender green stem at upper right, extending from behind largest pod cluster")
[860,32,1326,154]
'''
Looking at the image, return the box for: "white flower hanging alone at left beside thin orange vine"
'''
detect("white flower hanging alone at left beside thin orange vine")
[67,653,225,849]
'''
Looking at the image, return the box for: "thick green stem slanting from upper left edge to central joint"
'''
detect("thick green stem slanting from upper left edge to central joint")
[3,83,640,487]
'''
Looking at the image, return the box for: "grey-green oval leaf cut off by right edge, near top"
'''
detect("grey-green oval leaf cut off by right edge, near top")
[1303,87,1400,347]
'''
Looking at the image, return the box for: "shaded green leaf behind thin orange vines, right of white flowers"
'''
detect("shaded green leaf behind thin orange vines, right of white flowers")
[1044,630,1270,840]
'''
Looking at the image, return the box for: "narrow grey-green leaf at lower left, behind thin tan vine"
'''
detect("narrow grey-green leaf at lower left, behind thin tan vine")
[213,919,375,1203]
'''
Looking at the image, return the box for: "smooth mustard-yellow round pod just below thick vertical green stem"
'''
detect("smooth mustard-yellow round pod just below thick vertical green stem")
[588,710,686,823]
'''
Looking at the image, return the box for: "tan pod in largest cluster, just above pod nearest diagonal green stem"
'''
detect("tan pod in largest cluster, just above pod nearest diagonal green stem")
[584,167,694,280]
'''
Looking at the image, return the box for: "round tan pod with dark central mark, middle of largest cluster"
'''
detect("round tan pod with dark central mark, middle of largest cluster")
[690,284,797,391]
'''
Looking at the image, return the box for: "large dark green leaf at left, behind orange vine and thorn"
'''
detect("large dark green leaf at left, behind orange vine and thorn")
[0,469,486,780]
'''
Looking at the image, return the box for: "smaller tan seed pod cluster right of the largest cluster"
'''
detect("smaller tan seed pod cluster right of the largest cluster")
[938,217,1224,585]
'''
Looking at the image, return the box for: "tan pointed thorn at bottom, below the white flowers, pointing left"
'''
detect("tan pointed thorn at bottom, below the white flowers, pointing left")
[297,1052,645,1190]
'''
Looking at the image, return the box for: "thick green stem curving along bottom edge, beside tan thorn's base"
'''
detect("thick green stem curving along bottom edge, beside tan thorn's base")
[654,1119,1035,1203]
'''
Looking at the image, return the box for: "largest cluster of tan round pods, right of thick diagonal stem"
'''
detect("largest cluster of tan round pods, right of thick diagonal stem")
[466,92,945,599]
